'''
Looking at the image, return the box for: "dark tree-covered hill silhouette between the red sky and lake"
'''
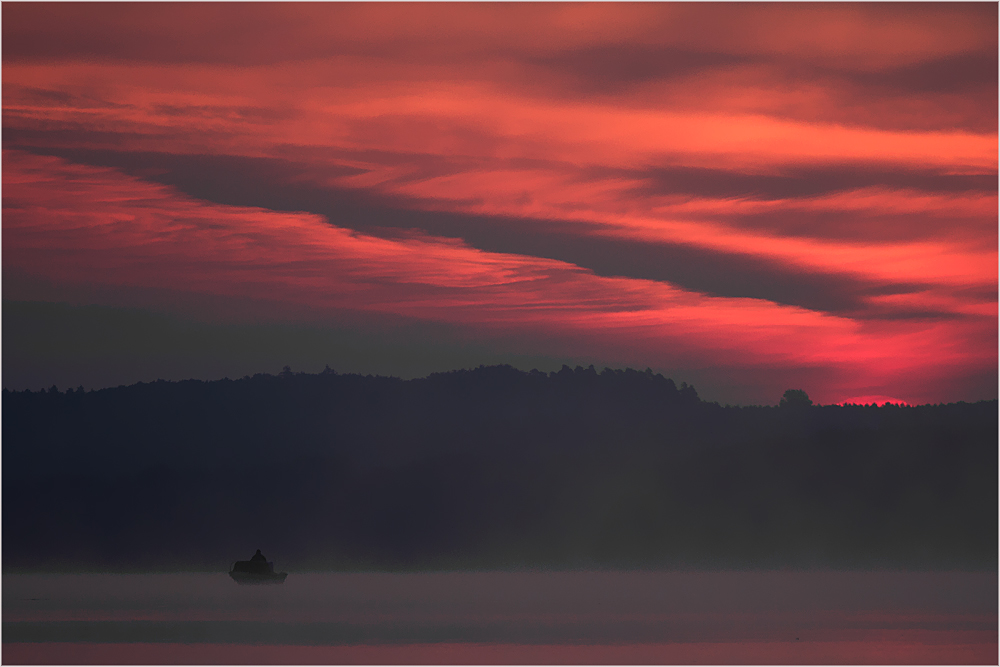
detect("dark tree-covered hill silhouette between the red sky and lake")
[3,366,998,570]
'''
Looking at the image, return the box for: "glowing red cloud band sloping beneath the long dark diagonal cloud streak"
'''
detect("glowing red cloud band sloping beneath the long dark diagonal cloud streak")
[3,151,996,402]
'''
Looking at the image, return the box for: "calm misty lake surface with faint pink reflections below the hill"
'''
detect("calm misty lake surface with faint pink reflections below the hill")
[3,572,997,664]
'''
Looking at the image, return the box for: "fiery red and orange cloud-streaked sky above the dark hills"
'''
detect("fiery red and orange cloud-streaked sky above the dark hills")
[2,3,998,404]
